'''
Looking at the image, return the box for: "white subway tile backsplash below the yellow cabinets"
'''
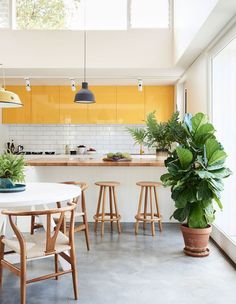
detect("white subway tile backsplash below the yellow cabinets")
[8,125,148,153]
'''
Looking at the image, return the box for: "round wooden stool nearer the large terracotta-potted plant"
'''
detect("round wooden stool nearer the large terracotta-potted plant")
[135,182,162,236]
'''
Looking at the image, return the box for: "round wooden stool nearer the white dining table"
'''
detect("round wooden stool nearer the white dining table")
[93,182,121,236]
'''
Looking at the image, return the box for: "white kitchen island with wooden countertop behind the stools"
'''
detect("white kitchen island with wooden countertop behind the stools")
[26,156,173,222]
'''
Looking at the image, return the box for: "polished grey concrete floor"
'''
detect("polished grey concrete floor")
[0,224,236,304]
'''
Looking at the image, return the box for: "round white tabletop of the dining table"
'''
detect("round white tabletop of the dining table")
[0,183,81,209]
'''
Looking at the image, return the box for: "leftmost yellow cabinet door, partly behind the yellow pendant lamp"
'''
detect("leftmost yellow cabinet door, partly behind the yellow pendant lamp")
[3,86,31,124]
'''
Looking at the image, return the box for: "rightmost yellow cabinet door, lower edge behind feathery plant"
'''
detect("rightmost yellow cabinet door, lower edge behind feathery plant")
[144,86,174,121]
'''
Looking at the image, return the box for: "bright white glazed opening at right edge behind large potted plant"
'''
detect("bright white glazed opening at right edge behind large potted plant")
[212,38,236,239]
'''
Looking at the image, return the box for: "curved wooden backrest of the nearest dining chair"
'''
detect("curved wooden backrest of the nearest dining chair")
[1,203,76,255]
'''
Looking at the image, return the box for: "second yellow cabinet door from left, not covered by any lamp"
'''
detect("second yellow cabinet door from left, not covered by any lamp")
[31,86,60,124]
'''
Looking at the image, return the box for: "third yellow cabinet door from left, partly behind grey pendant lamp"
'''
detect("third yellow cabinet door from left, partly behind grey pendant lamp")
[60,86,88,124]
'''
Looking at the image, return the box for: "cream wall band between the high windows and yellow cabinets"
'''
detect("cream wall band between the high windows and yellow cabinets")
[0,29,172,69]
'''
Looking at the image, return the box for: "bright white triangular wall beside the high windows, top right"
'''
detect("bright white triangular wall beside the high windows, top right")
[174,0,218,63]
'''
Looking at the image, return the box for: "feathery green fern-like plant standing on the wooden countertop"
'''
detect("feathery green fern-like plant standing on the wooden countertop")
[128,112,186,151]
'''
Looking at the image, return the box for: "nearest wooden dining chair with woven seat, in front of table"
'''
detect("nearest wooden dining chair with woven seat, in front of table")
[0,203,78,304]
